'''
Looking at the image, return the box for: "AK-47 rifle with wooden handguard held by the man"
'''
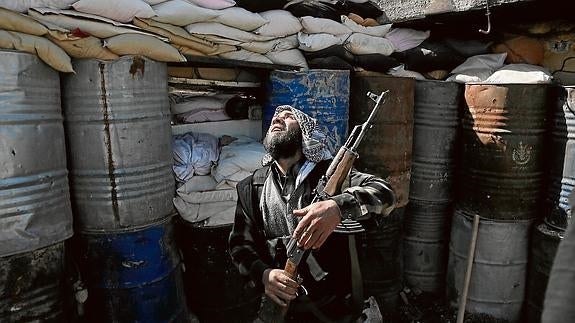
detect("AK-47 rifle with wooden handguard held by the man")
[259,91,389,323]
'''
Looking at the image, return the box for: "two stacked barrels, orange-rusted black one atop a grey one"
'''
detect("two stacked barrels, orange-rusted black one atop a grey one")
[447,84,551,322]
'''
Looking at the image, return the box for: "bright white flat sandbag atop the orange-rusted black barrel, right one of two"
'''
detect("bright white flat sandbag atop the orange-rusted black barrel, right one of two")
[484,64,553,84]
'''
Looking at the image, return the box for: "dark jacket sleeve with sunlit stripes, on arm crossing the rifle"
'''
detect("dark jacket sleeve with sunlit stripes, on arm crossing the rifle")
[331,170,395,220]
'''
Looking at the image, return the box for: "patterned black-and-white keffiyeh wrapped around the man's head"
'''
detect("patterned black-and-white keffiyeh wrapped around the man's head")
[262,105,333,166]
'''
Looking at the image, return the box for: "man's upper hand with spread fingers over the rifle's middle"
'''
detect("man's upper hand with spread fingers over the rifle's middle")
[293,200,341,249]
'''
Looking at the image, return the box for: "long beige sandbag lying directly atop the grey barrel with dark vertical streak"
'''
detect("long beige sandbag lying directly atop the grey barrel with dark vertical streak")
[104,34,186,62]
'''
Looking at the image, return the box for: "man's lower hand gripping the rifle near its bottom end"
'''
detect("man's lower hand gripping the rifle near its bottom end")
[262,269,298,307]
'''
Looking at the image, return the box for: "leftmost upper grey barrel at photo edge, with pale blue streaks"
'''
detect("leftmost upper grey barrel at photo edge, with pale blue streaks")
[0,51,72,256]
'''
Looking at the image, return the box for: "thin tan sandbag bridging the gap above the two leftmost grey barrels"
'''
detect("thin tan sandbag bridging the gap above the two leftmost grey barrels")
[47,36,120,60]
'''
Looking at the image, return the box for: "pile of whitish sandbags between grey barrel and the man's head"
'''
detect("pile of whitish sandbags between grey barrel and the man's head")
[173,132,265,226]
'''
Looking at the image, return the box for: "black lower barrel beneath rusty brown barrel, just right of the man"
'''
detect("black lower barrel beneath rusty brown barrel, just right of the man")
[357,208,405,312]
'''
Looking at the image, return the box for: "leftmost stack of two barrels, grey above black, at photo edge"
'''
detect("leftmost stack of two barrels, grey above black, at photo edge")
[0,51,74,322]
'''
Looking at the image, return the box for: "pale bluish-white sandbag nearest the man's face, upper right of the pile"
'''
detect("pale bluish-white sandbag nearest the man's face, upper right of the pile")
[212,136,265,187]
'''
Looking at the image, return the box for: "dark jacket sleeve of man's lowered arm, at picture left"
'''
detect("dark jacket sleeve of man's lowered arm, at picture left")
[229,176,270,288]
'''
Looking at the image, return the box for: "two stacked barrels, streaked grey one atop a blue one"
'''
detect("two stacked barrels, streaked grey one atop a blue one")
[62,57,189,322]
